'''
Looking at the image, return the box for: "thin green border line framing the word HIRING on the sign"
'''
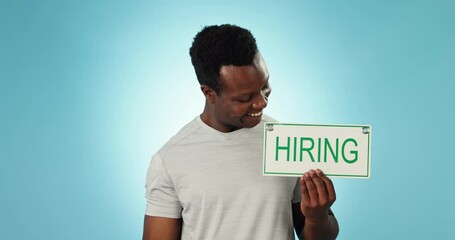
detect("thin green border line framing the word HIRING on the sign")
[263,122,371,178]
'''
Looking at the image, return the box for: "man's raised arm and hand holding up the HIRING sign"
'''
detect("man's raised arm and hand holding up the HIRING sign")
[292,169,339,240]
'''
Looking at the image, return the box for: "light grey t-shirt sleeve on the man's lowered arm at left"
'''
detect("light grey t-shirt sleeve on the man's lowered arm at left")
[145,154,182,218]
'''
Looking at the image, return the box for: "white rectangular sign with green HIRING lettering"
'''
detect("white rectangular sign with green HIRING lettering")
[263,122,371,178]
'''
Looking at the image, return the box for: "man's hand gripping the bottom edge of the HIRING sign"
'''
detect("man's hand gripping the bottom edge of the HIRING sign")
[300,169,336,223]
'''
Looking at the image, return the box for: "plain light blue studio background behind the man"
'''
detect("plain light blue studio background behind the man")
[0,0,455,240]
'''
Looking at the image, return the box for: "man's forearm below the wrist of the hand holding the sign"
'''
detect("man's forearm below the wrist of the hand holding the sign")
[300,215,339,240]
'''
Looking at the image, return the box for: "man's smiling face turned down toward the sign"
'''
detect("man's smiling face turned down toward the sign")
[211,54,271,132]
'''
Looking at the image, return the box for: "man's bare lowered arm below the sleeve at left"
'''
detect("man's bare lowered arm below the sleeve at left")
[142,215,182,240]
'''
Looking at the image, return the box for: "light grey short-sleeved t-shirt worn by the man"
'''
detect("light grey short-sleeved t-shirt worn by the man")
[145,116,300,240]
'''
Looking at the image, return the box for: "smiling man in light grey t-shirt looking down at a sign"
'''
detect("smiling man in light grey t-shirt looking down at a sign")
[143,25,338,240]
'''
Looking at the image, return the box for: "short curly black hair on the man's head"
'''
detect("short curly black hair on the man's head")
[190,24,258,94]
